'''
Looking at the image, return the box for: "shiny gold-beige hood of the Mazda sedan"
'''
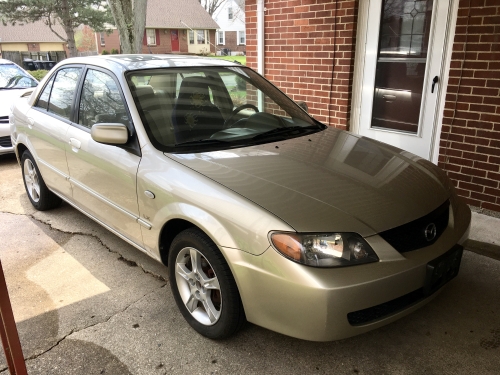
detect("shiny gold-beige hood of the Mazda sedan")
[167,128,452,236]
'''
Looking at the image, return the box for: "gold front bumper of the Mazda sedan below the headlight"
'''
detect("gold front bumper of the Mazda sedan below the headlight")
[223,198,471,341]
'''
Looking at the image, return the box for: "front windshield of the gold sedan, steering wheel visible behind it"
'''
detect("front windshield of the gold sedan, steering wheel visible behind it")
[127,67,325,153]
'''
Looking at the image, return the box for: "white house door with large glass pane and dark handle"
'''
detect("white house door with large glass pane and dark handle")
[358,0,450,159]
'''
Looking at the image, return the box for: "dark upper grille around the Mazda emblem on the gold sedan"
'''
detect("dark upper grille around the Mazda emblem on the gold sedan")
[380,200,450,253]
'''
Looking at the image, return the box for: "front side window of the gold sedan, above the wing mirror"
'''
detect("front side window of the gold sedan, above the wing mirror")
[78,69,130,129]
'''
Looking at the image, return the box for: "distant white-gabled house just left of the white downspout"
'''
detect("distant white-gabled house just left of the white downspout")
[212,0,246,55]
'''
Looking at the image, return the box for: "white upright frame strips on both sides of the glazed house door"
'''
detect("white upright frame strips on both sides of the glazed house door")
[350,0,459,164]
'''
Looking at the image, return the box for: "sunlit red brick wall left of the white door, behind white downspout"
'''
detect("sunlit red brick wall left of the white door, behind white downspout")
[245,0,358,129]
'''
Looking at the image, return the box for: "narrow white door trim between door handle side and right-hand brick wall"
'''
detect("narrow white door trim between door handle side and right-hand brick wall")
[430,0,459,164]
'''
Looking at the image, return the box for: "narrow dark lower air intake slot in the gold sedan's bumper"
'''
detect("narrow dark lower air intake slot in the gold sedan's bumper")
[347,288,425,326]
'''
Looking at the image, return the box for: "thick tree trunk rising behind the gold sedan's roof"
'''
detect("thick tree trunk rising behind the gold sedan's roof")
[108,0,147,53]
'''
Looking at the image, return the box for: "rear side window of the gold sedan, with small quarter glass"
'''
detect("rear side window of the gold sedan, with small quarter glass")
[36,67,82,120]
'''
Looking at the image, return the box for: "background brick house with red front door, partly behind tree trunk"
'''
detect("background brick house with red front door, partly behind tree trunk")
[96,0,219,54]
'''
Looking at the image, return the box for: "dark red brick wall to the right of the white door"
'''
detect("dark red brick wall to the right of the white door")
[439,0,500,211]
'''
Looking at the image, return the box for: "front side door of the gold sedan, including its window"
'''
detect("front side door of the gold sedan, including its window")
[66,68,142,247]
